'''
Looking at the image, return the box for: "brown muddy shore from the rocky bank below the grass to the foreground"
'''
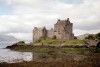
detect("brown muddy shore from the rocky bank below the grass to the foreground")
[0,44,100,67]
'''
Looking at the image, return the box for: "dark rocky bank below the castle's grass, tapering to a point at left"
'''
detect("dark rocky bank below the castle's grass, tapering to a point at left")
[6,45,92,52]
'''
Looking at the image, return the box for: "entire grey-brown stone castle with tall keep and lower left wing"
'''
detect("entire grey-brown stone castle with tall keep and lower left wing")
[33,18,74,41]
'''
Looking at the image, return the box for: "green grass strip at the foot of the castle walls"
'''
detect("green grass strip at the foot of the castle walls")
[33,39,86,45]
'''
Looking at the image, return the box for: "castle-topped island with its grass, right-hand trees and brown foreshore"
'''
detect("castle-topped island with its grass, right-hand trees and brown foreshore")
[0,18,100,67]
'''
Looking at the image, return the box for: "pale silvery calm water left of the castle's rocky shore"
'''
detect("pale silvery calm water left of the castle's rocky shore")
[0,42,32,63]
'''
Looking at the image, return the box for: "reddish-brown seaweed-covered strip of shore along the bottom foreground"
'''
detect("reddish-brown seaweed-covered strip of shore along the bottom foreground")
[0,53,100,67]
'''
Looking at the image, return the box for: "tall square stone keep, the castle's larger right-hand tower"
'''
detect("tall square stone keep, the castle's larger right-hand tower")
[54,18,73,40]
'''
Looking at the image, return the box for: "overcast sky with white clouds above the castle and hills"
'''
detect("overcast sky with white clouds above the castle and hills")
[0,0,100,40]
